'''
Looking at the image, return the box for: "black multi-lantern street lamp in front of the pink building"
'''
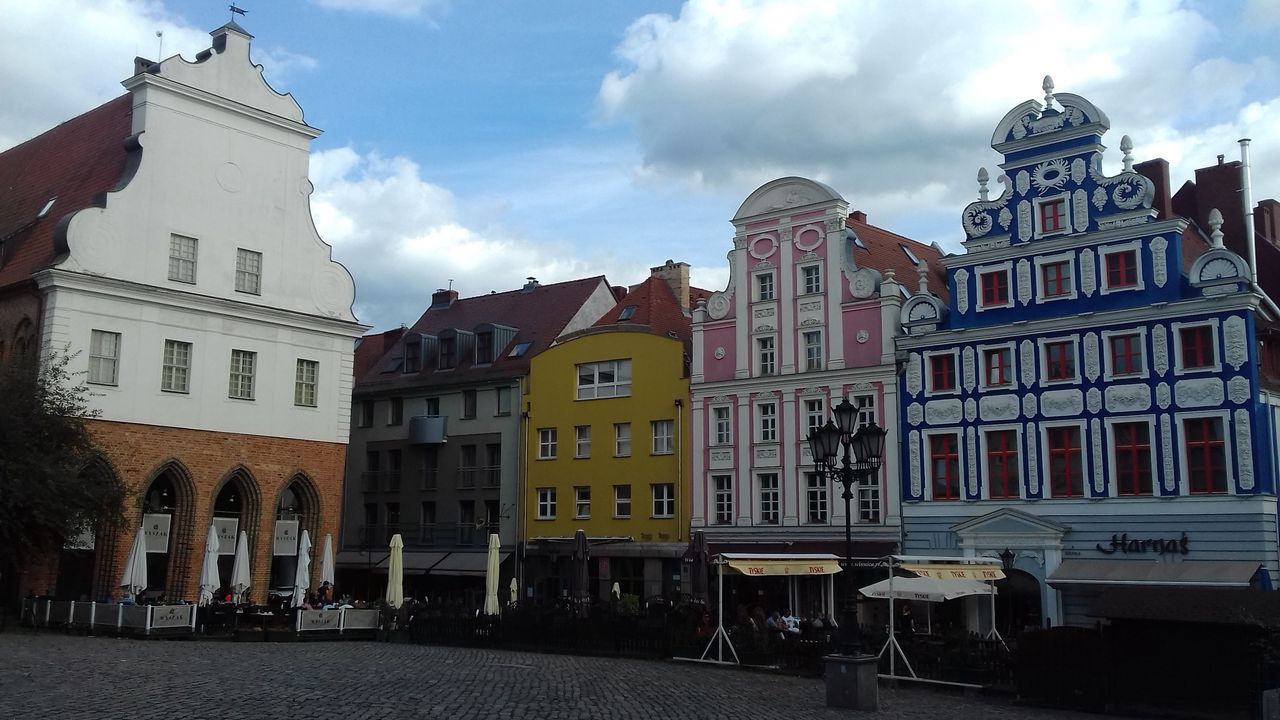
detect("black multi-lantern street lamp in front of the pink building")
[809,396,888,655]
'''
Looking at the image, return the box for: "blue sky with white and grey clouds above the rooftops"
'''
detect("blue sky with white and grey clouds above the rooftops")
[0,0,1280,331]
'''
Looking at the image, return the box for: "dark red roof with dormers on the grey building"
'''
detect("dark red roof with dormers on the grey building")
[356,275,608,392]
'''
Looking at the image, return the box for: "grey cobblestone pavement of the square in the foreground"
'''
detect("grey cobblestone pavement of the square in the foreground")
[0,628,1136,720]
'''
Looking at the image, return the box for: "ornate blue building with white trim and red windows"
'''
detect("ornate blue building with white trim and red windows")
[897,78,1280,630]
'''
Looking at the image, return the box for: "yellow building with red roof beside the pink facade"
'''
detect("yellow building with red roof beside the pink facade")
[521,261,690,602]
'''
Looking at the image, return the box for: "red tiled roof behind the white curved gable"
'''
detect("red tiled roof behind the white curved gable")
[0,95,133,287]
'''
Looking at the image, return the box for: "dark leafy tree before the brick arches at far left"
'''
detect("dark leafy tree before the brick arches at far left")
[0,351,125,599]
